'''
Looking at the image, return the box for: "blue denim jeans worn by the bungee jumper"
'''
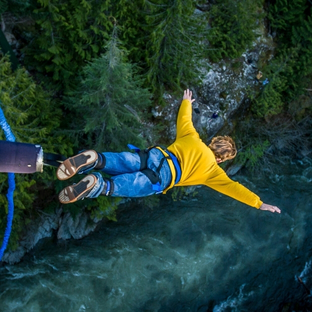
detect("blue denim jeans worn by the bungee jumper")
[87,148,172,198]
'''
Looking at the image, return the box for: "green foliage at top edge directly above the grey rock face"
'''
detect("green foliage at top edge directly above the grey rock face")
[207,0,263,62]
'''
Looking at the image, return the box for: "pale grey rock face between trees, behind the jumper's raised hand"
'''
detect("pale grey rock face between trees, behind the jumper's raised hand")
[153,30,274,140]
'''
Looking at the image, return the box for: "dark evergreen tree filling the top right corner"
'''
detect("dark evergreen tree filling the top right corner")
[269,0,312,98]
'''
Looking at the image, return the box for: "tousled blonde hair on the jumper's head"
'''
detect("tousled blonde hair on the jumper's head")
[209,135,237,161]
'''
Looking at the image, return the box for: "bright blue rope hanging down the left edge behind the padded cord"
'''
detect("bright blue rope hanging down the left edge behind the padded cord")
[0,101,15,261]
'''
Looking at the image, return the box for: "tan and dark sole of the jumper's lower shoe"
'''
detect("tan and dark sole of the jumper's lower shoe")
[59,174,97,204]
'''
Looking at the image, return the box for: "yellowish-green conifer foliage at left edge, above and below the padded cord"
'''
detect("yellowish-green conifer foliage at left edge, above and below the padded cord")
[0,56,72,248]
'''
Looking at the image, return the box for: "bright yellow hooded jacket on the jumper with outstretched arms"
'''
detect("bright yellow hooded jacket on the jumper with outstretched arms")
[158,100,262,209]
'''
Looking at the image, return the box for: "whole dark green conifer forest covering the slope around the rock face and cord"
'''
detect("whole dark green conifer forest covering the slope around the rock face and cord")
[0,0,312,250]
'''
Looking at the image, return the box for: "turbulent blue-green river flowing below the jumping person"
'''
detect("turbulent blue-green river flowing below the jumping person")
[0,161,312,312]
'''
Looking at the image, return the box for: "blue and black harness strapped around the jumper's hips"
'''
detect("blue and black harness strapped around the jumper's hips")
[128,144,181,194]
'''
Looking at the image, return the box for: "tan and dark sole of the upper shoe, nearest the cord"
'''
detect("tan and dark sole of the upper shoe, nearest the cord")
[56,150,98,181]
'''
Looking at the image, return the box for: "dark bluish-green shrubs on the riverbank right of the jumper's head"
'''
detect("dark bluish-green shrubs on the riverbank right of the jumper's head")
[232,112,312,175]
